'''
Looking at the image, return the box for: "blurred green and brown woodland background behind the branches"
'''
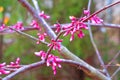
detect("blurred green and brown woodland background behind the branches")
[0,0,120,80]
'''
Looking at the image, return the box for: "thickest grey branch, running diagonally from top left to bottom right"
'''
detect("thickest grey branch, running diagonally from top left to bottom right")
[18,0,114,80]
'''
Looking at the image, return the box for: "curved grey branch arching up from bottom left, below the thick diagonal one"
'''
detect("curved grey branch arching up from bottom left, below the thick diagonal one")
[2,59,107,80]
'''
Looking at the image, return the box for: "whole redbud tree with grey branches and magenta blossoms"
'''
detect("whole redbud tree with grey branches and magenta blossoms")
[0,0,120,80]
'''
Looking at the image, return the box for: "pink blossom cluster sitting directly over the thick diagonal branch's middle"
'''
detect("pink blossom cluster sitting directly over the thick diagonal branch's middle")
[48,39,62,51]
